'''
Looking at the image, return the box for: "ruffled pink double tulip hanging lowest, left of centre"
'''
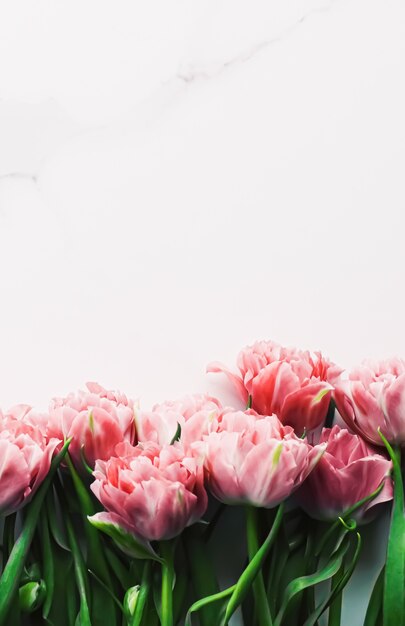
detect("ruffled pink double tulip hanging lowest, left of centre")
[91,443,207,541]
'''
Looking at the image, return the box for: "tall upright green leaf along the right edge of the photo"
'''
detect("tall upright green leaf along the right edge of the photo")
[379,430,405,626]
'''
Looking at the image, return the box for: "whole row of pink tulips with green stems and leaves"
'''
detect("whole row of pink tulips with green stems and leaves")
[0,341,405,626]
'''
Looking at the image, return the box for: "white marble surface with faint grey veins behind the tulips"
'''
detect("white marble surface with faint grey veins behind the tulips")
[0,0,405,626]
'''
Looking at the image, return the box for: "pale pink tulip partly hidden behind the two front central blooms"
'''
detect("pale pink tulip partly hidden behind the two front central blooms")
[135,394,222,447]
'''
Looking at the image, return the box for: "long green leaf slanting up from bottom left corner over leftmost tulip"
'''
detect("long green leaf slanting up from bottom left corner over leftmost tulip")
[0,439,71,624]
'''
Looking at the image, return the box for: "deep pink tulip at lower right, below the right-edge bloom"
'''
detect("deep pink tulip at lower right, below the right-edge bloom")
[297,426,392,522]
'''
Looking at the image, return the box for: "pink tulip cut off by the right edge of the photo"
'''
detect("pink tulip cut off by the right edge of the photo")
[335,358,405,446]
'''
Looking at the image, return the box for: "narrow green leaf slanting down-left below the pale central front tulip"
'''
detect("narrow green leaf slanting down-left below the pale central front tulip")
[224,502,284,626]
